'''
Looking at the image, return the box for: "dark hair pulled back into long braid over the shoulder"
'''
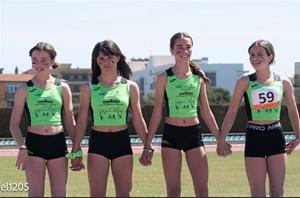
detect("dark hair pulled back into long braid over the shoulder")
[170,32,210,84]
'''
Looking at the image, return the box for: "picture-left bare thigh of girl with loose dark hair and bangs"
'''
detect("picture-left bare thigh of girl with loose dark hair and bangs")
[87,153,109,197]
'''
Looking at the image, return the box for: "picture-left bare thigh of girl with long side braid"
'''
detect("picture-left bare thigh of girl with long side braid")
[161,147,182,186]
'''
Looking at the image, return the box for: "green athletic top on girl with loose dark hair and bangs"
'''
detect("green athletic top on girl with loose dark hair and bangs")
[91,78,130,126]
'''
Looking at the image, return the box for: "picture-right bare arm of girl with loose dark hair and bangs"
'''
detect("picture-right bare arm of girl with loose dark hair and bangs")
[130,81,148,145]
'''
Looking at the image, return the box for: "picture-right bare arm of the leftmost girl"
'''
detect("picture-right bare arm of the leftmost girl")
[62,83,75,140]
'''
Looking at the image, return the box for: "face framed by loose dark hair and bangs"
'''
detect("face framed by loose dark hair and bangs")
[97,51,120,71]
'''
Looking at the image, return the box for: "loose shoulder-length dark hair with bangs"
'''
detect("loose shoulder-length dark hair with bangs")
[92,40,132,79]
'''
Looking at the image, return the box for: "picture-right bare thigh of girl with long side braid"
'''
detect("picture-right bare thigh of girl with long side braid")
[185,146,208,186]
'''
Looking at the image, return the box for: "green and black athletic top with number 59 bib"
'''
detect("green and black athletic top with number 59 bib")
[244,73,283,121]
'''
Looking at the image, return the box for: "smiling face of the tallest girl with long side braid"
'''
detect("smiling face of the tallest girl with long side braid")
[171,37,193,60]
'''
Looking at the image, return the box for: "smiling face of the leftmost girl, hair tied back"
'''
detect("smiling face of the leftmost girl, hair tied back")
[31,50,55,73]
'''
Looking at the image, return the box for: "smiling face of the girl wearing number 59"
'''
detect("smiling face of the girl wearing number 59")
[249,46,273,69]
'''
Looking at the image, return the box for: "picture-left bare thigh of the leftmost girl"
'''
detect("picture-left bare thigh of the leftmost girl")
[25,156,46,197]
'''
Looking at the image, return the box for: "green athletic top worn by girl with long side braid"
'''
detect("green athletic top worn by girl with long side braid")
[165,68,201,117]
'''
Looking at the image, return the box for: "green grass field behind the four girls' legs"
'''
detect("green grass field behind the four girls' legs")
[0,151,300,197]
